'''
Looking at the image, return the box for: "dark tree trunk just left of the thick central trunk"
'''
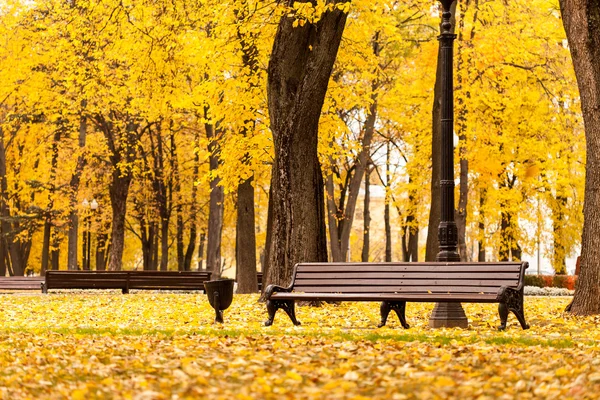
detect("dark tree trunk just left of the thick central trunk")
[236,177,258,293]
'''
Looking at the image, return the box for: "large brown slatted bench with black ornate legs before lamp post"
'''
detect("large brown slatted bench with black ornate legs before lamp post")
[265,262,529,329]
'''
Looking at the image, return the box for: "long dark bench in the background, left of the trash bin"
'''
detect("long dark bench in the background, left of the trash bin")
[42,270,211,293]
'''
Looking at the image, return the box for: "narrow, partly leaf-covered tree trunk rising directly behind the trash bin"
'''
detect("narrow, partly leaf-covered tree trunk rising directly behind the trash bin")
[204,113,225,279]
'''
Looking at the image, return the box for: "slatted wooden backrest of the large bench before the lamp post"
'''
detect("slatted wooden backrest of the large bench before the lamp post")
[292,262,528,293]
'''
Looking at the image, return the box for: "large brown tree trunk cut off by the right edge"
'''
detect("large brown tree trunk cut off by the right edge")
[560,0,600,315]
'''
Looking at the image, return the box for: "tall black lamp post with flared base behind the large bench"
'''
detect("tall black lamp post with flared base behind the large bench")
[429,0,469,328]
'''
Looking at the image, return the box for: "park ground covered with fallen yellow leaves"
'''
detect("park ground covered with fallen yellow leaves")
[0,292,600,400]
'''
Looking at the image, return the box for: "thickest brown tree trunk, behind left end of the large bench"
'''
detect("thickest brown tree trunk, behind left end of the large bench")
[263,0,347,285]
